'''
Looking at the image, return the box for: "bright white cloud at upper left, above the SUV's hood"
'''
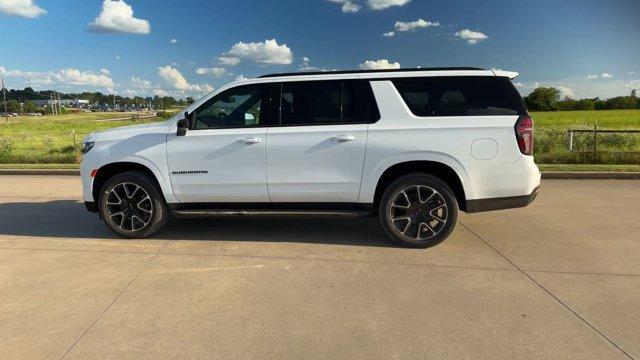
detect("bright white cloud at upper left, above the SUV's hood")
[88,0,151,34]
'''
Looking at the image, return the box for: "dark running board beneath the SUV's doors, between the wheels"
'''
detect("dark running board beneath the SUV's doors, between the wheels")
[173,209,372,218]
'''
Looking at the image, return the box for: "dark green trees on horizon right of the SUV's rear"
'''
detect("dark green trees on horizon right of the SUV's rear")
[524,87,640,111]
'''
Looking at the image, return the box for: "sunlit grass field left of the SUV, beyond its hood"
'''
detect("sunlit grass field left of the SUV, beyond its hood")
[0,113,160,164]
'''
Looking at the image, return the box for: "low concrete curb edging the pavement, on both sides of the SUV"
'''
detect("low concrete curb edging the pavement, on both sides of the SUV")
[0,169,640,180]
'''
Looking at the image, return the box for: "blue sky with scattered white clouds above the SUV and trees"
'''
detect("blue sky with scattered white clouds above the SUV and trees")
[0,0,640,97]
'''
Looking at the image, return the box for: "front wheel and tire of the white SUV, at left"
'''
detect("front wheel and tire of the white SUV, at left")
[99,171,169,239]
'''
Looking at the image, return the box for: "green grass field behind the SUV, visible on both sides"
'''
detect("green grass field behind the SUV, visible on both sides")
[0,110,640,166]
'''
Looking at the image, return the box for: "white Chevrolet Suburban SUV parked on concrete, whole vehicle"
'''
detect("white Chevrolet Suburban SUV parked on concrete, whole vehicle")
[82,68,540,247]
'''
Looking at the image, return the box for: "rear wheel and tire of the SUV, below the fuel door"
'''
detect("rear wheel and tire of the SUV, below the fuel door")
[379,173,458,248]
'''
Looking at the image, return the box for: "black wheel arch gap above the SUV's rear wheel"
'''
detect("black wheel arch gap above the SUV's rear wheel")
[373,160,467,211]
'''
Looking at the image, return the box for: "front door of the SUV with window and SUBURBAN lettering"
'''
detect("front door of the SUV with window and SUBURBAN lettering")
[167,84,273,203]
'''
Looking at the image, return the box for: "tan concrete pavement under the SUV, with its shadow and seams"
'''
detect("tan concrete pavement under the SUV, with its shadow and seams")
[0,176,640,359]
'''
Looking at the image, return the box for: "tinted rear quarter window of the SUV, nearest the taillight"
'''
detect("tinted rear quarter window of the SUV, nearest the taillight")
[393,76,527,117]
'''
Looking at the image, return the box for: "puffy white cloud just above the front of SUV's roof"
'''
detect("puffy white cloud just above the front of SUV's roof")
[224,39,293,65]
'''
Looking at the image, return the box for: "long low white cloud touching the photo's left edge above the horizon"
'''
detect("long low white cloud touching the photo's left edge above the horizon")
[2,68,115,88]
